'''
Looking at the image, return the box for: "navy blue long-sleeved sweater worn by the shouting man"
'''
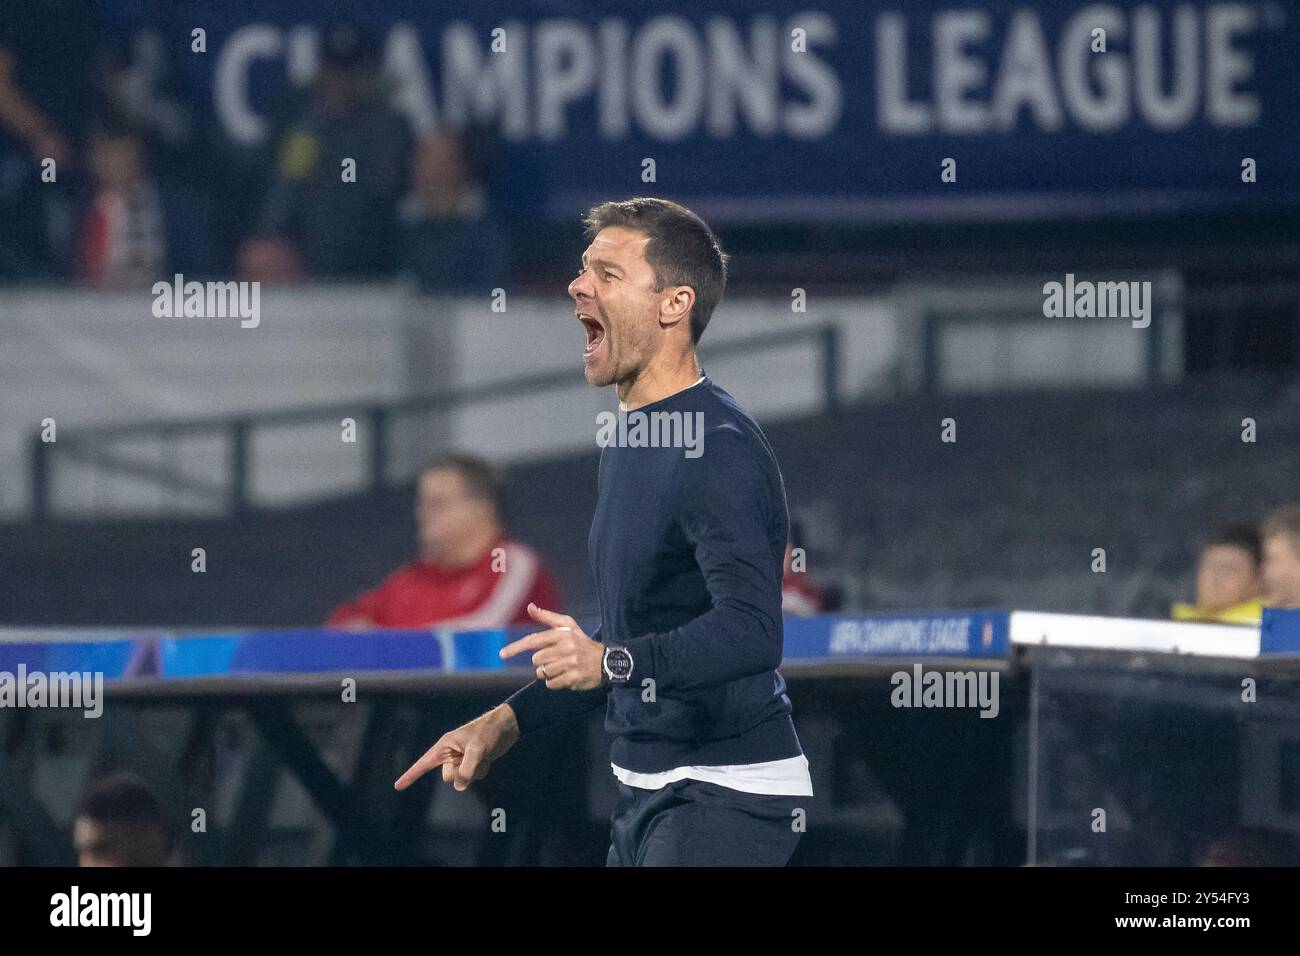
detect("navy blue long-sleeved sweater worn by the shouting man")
[507,377,802,773]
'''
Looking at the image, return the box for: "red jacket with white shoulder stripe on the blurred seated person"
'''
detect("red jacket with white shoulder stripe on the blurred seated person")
[328,540,559,631]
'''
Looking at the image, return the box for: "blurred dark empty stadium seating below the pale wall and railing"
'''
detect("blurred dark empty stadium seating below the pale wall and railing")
[0,378,1300,626]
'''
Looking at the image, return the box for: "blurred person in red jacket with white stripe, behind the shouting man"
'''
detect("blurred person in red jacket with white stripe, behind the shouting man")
[329,455,559,631]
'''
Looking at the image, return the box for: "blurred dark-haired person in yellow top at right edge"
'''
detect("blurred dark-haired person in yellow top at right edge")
[1173,524,1264,624]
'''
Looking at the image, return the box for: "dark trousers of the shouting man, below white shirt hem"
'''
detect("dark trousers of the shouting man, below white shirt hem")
[605,780,813,866]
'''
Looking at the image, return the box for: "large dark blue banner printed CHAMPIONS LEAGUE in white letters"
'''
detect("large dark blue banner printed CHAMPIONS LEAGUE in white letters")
[101,0,1300,222]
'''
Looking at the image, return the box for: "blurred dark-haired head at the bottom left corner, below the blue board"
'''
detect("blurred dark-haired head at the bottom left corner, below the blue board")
[73,773,173,866]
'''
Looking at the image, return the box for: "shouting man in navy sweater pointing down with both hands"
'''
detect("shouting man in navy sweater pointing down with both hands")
[397,198,813,866]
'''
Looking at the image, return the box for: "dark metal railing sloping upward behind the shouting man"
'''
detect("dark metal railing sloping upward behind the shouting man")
[30,324,840,522]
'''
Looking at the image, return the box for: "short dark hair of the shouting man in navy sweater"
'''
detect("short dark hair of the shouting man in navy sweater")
[582,196,731,343]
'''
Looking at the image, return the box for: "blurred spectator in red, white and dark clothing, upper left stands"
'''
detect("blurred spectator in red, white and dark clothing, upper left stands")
[77,125,166,289]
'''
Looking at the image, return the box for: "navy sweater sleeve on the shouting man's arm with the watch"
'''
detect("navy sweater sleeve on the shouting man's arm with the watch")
[616,427,785,693]
